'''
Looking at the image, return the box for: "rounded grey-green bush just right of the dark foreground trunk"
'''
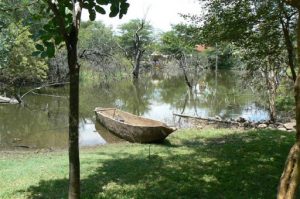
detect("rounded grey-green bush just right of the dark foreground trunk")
[79,21,131,80]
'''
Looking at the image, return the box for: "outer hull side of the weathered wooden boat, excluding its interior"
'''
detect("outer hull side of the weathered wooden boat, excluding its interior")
[95,109,174,143]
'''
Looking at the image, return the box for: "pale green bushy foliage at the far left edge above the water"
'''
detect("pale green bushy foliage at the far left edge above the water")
[0,0,48,86]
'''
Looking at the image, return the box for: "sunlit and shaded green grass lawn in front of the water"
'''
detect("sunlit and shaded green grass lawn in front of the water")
[0,130,294,199]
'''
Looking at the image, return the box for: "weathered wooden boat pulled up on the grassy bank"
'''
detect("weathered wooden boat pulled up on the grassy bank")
[95,108,176,143]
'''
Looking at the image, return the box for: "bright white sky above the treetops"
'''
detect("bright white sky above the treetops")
[82,0,201,31]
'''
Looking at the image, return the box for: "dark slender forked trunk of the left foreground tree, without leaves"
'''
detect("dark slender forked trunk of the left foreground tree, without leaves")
[46,0,82,199]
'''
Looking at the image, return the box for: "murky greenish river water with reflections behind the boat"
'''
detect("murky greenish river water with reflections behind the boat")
[0,71,268,150]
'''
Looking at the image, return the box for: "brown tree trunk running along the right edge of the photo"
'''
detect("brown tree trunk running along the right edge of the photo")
[277,0,300,199]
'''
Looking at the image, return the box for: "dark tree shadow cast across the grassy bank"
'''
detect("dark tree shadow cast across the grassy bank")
[23,131,293,199]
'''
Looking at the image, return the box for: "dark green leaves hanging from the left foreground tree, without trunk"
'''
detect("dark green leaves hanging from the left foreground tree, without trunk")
[32,0,129,57]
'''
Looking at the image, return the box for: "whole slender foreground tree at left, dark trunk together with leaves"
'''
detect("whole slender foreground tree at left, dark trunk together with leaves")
[44,0,129,199]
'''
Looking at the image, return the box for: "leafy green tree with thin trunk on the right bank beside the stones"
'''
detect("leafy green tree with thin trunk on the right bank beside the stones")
[185,0,296,121]
